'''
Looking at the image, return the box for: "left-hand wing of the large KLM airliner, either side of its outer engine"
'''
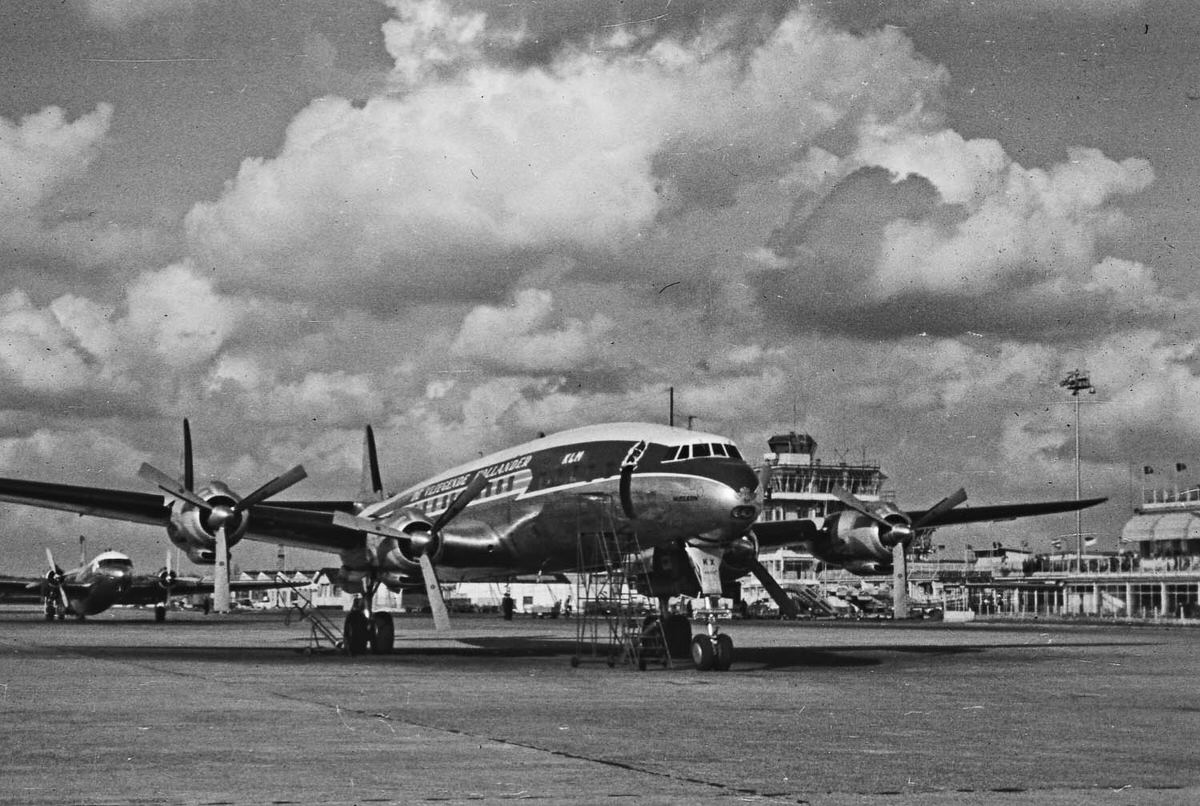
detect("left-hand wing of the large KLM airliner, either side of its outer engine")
[0,479,361,552]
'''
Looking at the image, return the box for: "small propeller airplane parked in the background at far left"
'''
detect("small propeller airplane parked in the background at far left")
[0,548,297,621]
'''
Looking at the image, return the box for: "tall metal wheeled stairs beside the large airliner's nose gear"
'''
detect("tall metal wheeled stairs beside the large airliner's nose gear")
[571,493,671,669]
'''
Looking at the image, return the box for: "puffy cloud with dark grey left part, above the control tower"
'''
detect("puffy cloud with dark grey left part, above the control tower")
[755,116,1161,338]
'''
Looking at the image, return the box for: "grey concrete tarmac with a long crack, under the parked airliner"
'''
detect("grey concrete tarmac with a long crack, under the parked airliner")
[0,607,1200,806]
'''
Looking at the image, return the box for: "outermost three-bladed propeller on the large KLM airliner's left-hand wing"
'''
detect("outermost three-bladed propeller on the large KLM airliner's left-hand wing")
[138,419,308,613]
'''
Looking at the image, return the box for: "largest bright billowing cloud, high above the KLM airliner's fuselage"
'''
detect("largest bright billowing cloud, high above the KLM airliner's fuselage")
[187,2,946,302]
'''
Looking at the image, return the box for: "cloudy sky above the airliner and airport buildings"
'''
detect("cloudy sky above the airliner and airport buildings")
[0,0,1200,572]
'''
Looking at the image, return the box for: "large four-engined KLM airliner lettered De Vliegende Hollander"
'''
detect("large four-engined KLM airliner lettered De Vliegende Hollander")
[0,420,1106,670]
